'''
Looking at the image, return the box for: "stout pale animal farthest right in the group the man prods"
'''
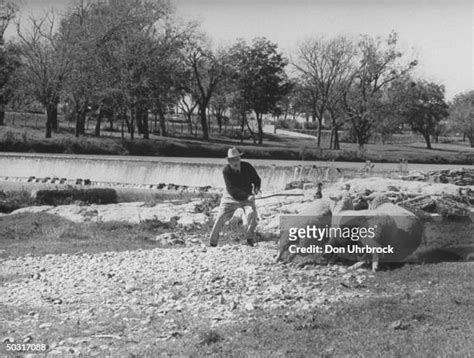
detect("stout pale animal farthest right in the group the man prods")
[328,193,423,271]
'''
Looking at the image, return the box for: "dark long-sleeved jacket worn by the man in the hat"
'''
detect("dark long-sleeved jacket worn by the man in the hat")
[222,162,262,201]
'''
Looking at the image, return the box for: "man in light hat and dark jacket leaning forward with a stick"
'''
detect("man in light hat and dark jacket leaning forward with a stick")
[210,147,261,246]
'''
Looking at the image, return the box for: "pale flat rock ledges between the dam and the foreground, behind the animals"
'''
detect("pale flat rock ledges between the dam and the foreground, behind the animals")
[4,177,474,248]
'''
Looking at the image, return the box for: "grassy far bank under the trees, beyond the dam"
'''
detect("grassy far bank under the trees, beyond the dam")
[0,116,474,164]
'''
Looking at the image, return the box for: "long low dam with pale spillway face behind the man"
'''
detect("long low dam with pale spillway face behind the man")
[0,153,470,191]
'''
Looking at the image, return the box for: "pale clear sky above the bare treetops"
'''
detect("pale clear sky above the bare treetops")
[6,0,474,99]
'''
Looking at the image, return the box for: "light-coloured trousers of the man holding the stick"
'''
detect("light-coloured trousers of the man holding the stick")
[209,193,257,245]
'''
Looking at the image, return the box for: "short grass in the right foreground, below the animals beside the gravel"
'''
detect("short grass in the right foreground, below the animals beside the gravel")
[207,263,474,357]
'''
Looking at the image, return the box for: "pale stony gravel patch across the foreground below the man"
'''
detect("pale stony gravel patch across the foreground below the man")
[0,243,373,356]
